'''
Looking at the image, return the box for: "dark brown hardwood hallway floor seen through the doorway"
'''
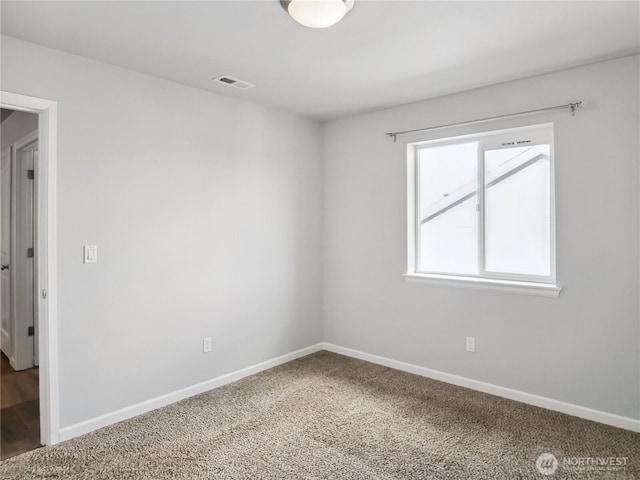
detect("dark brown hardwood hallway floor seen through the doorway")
[0,354,40,460]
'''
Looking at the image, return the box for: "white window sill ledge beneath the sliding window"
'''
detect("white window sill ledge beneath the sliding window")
[404,273,562,297]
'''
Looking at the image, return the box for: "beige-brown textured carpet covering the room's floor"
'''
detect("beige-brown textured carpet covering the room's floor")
[0,352,640,480]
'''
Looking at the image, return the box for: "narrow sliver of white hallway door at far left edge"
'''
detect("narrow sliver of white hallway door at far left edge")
[0,148,13,358]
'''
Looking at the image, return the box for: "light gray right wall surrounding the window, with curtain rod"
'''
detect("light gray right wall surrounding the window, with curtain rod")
[323,56,640,419]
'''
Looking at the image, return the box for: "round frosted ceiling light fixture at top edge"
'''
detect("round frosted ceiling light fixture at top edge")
[280,0,354,28]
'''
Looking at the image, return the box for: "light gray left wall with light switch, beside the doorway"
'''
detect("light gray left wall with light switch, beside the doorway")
[2,37,322,427]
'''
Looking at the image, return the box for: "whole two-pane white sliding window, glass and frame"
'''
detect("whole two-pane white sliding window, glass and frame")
[407,124,560,295]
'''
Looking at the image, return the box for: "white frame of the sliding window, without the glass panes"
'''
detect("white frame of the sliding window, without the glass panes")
[405,123,562,297]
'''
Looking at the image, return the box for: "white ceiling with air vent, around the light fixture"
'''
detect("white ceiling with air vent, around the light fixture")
[1,0,640,120]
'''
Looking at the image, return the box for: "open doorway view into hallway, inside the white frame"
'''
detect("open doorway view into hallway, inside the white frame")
[0,109,41,460]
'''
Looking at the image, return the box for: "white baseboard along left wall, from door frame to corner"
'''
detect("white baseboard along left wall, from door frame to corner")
[59,343,323,442]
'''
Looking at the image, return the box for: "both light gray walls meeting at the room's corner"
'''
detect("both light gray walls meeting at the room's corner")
[1,33,640,427]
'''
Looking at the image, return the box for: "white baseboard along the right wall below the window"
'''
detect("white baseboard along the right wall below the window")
[322,343,640,432]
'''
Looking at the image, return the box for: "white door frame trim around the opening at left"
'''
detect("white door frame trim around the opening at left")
[0,91,60,445]
